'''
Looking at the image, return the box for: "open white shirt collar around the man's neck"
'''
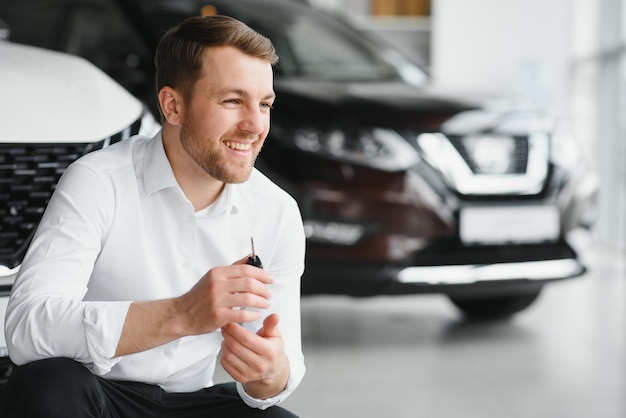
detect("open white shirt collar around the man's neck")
[144,131,240,214]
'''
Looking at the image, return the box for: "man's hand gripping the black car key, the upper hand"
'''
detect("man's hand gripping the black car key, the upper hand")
[177,253,273,335]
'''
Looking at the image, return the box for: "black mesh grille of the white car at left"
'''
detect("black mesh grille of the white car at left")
[0,120,140,268]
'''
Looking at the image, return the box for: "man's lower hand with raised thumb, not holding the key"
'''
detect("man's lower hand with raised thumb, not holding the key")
[220,314,289,399]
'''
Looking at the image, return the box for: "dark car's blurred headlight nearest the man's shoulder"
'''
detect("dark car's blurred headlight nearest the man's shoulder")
[272,127,419,171]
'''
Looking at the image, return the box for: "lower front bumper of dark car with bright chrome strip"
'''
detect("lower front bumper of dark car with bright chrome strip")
[302,237,586,297]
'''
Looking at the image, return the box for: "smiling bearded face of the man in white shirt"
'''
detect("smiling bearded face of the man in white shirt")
[181,47,275,183]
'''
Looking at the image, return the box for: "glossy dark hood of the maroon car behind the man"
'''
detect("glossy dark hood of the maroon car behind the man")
[273,78,480,130]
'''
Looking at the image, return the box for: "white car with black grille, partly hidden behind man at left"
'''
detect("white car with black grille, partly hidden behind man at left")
[0,36,160,384]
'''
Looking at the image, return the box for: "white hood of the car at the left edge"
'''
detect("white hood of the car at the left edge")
[0,41,143,142]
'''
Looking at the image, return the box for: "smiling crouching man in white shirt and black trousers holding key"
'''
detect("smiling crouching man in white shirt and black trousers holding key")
[5,16,305,418]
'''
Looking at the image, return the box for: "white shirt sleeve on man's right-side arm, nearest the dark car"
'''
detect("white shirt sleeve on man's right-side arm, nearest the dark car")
[237,196,306,409]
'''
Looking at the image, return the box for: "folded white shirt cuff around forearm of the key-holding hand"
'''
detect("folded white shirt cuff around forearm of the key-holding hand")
[83,302,131,376]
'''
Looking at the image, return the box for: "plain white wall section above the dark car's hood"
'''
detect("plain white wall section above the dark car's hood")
[431,0,571,111]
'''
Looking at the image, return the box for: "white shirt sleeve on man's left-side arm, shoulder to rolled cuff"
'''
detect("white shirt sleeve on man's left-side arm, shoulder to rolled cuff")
[5,163,130,374]
